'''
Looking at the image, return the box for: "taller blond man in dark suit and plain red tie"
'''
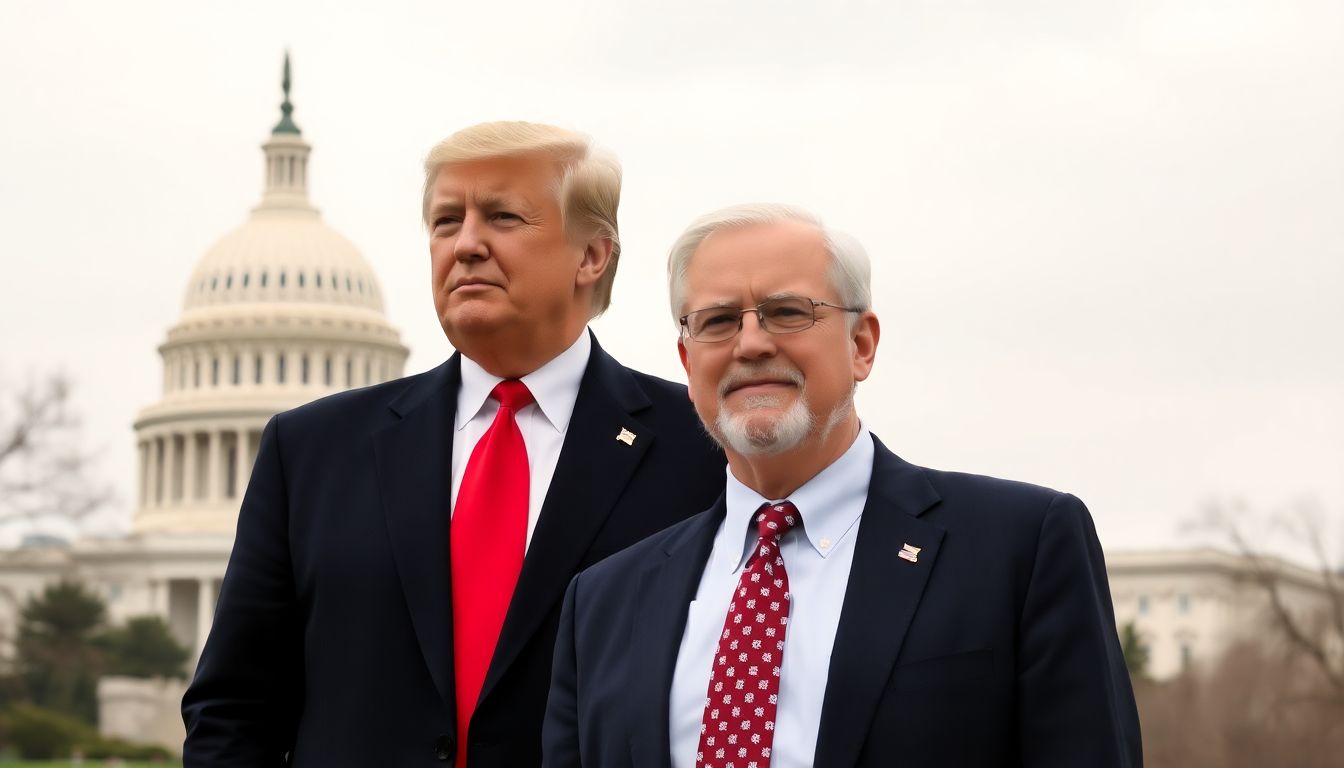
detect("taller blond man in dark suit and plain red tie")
[183,122,723,768]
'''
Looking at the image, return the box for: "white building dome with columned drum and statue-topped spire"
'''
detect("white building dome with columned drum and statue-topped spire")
[134,58,407,535]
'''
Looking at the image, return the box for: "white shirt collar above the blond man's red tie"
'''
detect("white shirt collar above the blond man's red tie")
[453,330,593,433]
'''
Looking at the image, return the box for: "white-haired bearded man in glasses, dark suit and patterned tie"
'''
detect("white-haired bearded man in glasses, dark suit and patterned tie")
[543,206,1142,768]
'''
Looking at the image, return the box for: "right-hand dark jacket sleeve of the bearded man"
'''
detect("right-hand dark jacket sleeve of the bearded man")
[1017,494,1142,768]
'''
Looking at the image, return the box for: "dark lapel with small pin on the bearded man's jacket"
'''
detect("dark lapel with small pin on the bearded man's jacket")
[814,437,943,768]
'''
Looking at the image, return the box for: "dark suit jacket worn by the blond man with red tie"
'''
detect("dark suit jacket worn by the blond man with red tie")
[183,339,724,768]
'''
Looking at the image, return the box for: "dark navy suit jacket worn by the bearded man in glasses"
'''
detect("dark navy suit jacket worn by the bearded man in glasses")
[543,438,1142,768]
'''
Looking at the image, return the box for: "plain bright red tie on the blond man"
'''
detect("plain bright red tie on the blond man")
[449,379,532,768]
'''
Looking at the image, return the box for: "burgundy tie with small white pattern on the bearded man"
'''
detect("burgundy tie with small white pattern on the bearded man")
[695,502,801,768]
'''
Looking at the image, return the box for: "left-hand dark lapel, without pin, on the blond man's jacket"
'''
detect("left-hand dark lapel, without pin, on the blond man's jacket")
[374,355,461,712]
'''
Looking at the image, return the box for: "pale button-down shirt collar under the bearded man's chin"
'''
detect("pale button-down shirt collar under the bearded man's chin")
[724,424,875,573]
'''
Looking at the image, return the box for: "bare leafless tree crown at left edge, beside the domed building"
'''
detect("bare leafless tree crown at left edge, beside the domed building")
[0,374,112,532]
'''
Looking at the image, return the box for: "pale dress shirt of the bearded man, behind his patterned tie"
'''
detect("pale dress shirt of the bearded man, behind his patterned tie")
[668,425,874,768]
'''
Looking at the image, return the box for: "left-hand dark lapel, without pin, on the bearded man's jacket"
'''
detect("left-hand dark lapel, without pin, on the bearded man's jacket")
[624,495,726,768]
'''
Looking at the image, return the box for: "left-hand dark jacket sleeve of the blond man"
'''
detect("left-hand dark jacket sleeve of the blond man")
[181,417,304,768]
